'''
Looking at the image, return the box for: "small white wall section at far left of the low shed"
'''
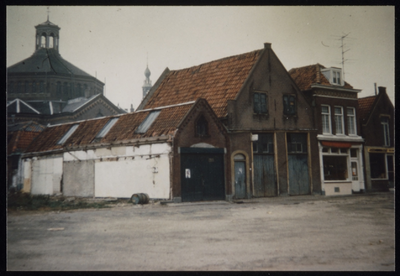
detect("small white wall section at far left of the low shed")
[31,156,63,195]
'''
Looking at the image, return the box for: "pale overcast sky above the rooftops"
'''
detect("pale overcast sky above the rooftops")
[7,6,395,109]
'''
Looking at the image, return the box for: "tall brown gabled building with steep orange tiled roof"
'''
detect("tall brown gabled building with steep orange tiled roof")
[138,43,321,199]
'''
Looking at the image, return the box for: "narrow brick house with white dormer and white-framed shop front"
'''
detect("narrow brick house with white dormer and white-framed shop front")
[289,64,365,195]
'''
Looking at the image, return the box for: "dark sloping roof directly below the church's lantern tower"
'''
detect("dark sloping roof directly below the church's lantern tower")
[7,48,92,77]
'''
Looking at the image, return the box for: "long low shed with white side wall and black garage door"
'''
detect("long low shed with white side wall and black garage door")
[21,99,229,201]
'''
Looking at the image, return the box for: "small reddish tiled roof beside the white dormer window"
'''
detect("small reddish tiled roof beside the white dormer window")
[289,63,353,91]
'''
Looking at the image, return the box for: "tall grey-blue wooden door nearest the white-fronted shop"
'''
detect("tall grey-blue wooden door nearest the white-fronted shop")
[287,133,311,195]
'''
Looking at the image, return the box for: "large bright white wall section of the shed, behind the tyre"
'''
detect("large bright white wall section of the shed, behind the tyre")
[64,143,171,199]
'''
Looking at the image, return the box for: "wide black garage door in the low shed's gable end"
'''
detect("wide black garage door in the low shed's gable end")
[181,148,225,201]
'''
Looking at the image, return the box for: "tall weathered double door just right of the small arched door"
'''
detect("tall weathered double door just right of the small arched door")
[253,134,277,197]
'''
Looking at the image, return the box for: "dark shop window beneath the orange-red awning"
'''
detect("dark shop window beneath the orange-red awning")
[323,155,347,180]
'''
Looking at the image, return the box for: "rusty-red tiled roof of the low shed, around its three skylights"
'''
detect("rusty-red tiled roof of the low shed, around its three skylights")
[27,103,194,152]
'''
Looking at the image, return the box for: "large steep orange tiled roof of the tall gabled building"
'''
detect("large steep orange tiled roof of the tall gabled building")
[143,50,263,117]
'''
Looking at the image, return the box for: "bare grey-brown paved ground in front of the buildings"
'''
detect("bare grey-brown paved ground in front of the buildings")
[7,193,395,271]
